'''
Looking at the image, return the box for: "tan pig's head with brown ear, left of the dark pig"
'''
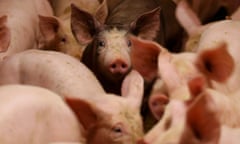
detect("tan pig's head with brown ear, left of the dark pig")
[39,15,81,59]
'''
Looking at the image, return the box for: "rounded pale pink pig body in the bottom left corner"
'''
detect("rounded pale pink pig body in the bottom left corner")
[0,85,85,144]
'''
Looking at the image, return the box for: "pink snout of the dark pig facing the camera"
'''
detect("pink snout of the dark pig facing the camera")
[109,59,130,74]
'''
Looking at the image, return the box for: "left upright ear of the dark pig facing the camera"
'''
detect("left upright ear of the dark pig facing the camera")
[71,4,100,45]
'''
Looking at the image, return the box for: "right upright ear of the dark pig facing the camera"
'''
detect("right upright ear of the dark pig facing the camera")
[130,7,160,40]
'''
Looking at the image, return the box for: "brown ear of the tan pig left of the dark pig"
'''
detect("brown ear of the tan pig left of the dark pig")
[39,15,60,41]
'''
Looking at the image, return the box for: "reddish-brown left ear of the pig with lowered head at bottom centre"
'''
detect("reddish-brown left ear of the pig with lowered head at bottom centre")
[65,98,98,130]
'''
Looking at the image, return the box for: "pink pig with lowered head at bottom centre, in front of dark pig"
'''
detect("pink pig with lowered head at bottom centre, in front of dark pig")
[0,50,143,144]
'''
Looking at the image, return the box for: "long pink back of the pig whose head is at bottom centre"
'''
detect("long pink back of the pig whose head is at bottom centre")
[0,50,104,98]
